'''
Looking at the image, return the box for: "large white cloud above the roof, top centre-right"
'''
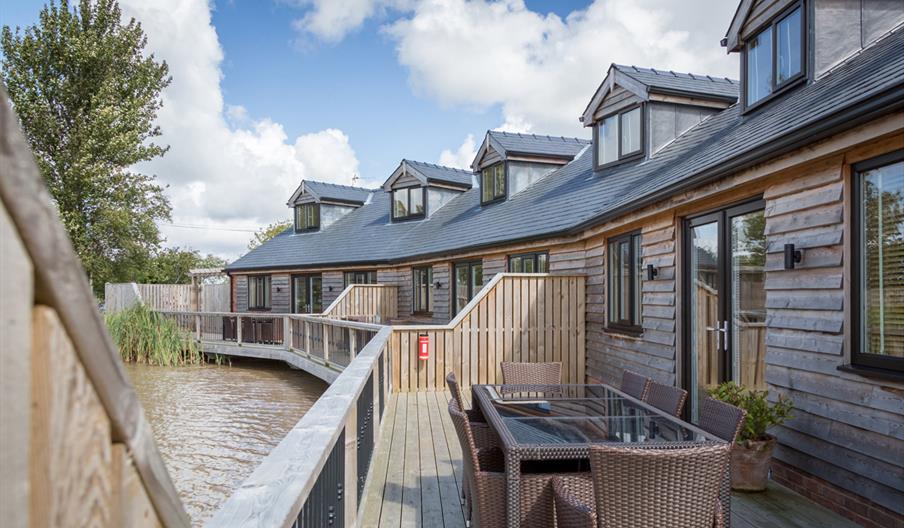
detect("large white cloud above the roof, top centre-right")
[384,0,737,135]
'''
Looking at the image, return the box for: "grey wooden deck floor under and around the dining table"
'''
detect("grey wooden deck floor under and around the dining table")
[360,392,857,528]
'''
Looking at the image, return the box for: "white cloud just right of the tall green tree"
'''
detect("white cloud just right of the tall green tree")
[122,0,358,258]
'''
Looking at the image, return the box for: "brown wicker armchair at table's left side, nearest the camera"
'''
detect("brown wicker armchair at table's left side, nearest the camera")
[449,400,593,528]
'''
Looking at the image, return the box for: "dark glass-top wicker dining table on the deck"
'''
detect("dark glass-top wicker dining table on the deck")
[471,385,728,527]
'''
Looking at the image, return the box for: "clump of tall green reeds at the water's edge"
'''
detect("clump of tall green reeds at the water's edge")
[104,304,204,367]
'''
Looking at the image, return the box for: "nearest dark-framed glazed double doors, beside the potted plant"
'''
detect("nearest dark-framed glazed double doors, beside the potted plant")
[684,200,766,421]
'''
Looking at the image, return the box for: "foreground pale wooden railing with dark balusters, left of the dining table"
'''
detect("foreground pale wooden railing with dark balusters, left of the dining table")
[207,326,391,528]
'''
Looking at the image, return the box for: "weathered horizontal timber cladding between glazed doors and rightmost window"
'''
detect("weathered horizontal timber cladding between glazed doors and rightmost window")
[764,157,904,513]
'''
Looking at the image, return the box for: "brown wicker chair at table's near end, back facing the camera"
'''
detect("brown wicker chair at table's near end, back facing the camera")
[553,444,730,528]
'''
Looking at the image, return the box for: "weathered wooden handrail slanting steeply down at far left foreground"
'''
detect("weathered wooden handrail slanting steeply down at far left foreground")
[0,86,189,526]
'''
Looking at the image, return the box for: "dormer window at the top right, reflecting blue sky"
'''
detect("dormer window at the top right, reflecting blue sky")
[744,4,806,107]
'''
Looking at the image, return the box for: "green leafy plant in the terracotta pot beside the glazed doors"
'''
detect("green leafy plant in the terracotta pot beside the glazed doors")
[709,381,794,444]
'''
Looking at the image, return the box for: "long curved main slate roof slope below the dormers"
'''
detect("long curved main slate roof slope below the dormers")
[227,26,904,270]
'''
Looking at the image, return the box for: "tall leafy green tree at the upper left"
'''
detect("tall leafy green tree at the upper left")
[0,0,170,294]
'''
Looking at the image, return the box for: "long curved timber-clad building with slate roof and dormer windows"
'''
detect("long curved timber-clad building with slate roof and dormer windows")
[222,0,904,526]
